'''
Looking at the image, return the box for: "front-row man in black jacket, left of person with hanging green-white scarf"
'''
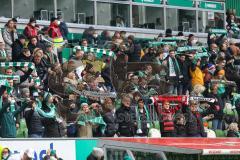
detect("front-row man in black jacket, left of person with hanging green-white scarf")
[116,95,137,137]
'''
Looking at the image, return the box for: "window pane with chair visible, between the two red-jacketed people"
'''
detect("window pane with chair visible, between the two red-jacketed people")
[34,0,54,20]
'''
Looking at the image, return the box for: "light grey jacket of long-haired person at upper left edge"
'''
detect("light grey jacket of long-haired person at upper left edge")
[2,27,18,50]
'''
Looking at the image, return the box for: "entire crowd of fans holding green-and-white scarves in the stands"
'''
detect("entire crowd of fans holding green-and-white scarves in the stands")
[0,12,240,138]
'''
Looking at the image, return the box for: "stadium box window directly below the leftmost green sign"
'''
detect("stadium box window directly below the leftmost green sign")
[132,6,164,29]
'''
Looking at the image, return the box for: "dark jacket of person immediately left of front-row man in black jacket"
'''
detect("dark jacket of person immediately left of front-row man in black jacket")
[103,111,118,137]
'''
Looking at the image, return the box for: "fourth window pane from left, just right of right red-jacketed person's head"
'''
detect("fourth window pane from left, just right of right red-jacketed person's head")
[57,0,75,22]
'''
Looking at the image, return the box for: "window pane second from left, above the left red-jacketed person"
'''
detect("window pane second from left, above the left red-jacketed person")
[13,0,34,19]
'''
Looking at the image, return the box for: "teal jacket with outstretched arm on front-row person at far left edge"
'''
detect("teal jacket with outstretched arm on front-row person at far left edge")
[0,98,25,138]
